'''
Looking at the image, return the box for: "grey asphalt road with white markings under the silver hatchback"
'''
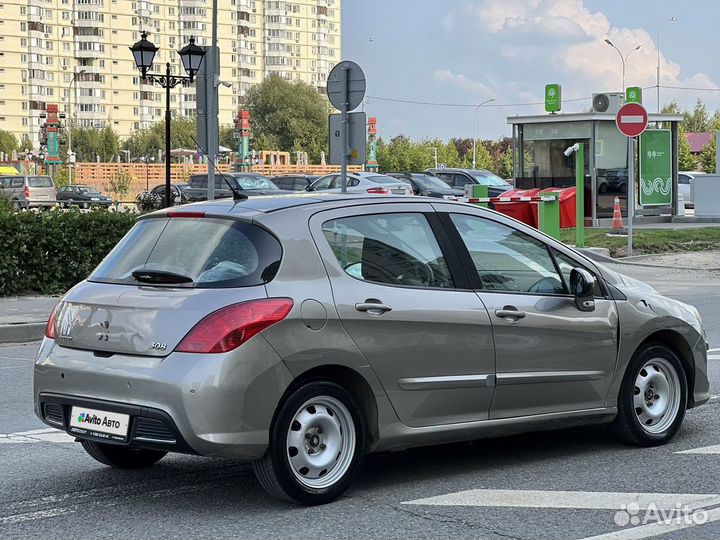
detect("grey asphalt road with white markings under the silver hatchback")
[0,266,720,540]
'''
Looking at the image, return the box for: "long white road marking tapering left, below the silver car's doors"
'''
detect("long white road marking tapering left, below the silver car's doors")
[402,489,720,510]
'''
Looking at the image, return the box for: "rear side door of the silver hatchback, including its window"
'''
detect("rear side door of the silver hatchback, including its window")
[310,204,495,427]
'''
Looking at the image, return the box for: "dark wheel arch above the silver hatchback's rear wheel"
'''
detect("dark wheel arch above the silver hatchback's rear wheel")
[273,364,380,448]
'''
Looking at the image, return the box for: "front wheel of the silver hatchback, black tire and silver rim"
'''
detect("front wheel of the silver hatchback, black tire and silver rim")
[611,343,688,446]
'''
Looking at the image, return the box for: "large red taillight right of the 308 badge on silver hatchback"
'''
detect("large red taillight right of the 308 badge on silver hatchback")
[175,298,293,353]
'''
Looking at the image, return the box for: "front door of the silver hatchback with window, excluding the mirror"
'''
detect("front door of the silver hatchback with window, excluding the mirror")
[443,209,618,418]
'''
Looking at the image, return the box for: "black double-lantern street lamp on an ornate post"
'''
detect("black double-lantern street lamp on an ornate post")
[130,32,205,207]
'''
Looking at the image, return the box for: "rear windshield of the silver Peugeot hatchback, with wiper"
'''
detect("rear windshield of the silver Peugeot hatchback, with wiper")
[88,217,282,289]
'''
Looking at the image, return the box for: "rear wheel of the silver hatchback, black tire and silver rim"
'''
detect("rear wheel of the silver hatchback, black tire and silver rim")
[253,381,366,505]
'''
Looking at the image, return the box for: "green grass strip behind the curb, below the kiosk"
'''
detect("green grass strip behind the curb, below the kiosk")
[560,227,720,257]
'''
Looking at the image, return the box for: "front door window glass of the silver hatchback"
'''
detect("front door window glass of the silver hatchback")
[450,214,568,294]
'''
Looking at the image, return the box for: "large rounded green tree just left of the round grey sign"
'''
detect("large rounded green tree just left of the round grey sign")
[247,75,330,163]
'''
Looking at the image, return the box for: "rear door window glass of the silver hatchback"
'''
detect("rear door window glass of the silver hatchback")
[323,213,454,288]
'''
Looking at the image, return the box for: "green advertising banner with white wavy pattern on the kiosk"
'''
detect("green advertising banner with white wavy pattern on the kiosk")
[639,129,672,206]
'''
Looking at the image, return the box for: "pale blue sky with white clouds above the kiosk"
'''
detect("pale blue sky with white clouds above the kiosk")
[342,0,720,139]
